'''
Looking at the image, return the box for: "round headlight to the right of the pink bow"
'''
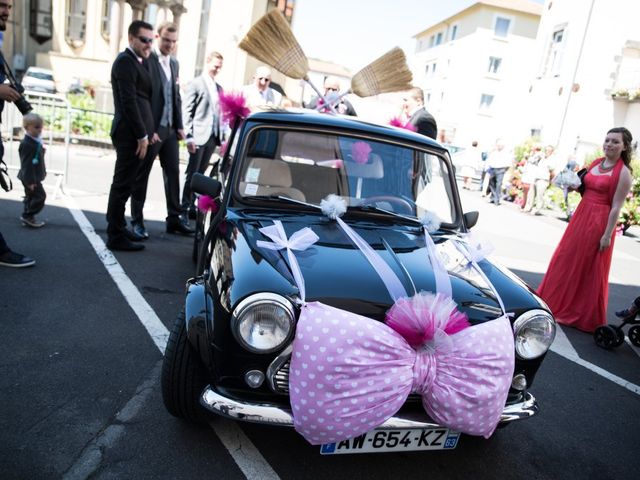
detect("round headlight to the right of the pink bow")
[513,310,556,360]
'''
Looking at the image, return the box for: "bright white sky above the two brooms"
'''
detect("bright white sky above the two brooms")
[292,0,544,73]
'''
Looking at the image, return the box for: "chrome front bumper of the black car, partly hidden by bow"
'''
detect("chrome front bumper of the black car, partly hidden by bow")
[200,386,538,430]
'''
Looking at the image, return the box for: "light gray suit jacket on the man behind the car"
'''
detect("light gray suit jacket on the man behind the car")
[182,73,223,145]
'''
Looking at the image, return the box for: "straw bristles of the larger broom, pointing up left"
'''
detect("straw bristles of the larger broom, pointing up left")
[239,9,309,79]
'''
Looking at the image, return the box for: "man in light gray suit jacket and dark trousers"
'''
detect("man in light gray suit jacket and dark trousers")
[182,52,223,219]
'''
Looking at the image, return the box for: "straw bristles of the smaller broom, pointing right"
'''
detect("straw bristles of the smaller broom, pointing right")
[351,47,413,97]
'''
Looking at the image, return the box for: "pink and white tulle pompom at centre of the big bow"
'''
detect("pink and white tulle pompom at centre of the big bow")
[385,292,469,349]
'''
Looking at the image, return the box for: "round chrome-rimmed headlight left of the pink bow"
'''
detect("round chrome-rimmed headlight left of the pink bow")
[231,293,295,353]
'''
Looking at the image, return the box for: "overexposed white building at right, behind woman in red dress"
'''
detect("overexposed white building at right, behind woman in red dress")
[529,0,640,163]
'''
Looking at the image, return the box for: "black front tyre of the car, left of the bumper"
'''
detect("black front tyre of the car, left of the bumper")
[161,310,208,423]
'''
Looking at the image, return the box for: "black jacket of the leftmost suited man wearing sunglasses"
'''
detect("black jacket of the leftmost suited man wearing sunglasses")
[111,48,154,145]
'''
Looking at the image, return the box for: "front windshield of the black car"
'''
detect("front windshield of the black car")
[236,127,457,223]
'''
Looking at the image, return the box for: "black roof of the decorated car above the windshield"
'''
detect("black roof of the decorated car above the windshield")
[247,108,444,149]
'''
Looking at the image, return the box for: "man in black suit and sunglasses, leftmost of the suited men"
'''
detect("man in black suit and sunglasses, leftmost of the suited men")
[107,20,154,251]
